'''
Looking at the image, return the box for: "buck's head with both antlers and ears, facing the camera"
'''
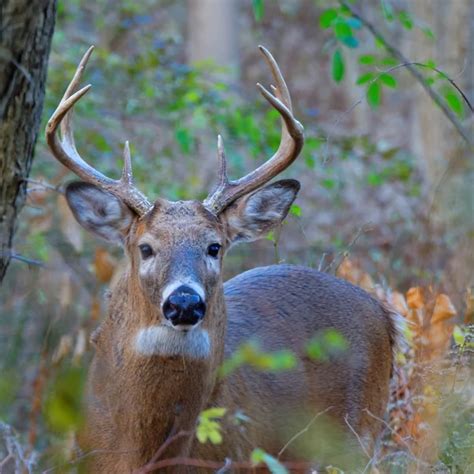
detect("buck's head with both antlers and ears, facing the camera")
[46,46,303,360]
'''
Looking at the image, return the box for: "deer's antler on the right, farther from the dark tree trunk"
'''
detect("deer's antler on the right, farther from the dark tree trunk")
[204,46,304,214]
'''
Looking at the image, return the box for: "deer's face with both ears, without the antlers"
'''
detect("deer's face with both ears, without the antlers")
[66,180,299,331]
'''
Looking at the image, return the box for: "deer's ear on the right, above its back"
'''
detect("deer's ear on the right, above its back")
[221,179,300,244]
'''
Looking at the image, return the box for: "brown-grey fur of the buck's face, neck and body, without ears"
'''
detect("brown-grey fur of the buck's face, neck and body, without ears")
[76,195,395,473]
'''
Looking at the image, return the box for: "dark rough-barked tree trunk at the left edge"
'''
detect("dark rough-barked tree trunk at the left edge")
[0,0,56,283]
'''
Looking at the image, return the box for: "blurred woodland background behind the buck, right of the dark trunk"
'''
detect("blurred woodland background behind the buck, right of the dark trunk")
[0,0,474,472]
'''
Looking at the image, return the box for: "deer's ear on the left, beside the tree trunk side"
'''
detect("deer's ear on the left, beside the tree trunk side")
[66,181,135,244]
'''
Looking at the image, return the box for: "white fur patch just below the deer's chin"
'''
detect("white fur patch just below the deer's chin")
[135,324,211,359]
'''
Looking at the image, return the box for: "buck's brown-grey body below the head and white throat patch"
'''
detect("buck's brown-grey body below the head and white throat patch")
[85,265,395,472]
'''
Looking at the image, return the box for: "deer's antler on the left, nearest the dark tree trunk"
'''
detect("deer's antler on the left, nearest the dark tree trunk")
[46,46,152,216]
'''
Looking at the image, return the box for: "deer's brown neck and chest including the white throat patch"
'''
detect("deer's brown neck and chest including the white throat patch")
[91,268,226,462]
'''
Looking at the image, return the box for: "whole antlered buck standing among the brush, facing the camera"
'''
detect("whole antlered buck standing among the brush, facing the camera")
[46,47,397,473]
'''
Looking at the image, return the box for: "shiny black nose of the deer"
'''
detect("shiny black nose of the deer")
[163,286,206,326]
